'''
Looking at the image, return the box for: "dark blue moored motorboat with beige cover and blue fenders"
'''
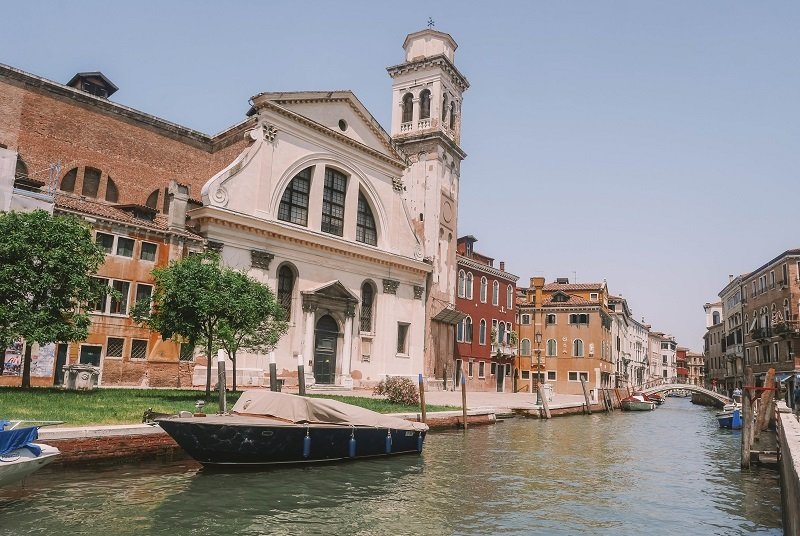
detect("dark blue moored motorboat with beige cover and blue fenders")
[155,390,428,466]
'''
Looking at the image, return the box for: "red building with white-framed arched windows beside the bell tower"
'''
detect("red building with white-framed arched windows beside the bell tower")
[455,235,519,392]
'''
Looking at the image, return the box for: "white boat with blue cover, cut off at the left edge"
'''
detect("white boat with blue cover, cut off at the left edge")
[0,420,60,487]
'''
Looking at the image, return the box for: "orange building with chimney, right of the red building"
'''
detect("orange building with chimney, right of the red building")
[515,277,614,401]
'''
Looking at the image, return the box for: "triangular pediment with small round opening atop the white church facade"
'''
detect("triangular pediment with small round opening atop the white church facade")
[248,91,404,160]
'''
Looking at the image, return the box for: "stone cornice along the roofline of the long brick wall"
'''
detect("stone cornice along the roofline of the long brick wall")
[0,64,254,152]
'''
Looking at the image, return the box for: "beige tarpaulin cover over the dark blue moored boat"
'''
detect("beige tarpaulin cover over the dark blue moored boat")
[231,390,428,431]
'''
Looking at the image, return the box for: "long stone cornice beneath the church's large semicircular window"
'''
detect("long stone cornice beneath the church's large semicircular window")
[188,207,433,276]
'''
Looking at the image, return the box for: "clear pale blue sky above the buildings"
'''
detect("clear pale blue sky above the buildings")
[0,0,800,351]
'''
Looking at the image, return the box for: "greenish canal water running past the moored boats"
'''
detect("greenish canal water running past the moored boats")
[0,398,782,536]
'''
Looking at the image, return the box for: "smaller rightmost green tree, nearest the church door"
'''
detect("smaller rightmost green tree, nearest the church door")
[219,268,288,391]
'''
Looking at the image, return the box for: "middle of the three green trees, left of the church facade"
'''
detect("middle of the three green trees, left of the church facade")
[131,252,232,396]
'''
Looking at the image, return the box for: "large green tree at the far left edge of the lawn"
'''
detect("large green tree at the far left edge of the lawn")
[0,210,105,387]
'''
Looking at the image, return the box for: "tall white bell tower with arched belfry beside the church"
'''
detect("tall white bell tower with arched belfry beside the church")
[387,29,469,387]
